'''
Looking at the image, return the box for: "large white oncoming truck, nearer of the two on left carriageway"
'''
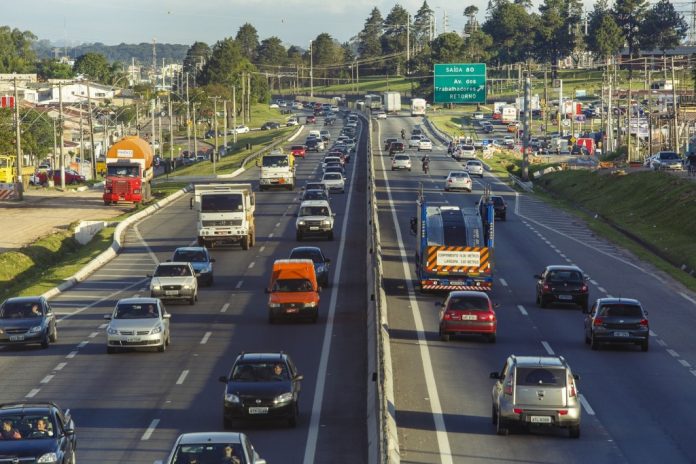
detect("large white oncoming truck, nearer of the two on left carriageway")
[190,183,256,250]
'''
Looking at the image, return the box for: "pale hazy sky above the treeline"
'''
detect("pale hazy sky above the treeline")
[0,0,589,47]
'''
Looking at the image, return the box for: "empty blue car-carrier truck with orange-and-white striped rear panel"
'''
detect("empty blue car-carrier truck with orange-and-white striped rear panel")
[411,190,494,292]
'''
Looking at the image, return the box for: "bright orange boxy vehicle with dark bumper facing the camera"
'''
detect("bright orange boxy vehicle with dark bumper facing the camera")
[266,259,321,324]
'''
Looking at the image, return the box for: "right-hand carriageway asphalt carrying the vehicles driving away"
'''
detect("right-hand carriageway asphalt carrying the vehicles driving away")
[372,117,696,463]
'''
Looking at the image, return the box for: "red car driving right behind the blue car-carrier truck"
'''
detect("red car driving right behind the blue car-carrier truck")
[436,290,498,343]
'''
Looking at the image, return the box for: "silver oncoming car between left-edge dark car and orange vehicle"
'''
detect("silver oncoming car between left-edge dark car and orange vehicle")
[104,298,171,353]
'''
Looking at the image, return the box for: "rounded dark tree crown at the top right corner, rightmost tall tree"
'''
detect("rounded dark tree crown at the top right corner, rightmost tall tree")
[640,0,689,55]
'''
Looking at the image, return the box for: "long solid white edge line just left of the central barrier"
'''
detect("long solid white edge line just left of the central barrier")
[302,119,358,464]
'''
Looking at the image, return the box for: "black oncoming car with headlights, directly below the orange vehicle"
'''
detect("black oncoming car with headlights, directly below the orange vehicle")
[219,351,303,429]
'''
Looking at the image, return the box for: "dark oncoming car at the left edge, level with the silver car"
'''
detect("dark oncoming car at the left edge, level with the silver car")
[0,296,58,348]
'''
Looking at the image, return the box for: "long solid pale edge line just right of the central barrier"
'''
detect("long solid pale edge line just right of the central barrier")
[372,121,454,464]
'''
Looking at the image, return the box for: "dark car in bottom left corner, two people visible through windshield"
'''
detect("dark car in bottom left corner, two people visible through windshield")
[0,402,77,464]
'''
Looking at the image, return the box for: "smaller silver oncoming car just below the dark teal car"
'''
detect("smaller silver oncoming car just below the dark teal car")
[147,261,198,304]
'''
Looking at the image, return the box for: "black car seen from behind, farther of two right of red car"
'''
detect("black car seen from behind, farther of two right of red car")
[534,264,589,311]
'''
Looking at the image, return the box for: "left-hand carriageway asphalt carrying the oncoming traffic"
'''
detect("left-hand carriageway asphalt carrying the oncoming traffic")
[0,114,367,464]
